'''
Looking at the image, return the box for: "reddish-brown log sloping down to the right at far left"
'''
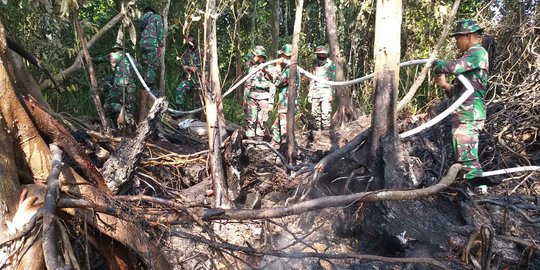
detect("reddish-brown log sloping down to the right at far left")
[23,98,111,194]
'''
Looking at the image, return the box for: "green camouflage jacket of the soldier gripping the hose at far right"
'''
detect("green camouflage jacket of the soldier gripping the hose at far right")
[433,43,489,121]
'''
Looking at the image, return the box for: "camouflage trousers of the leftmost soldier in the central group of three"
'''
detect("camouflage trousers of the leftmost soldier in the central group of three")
[246,97,269,138]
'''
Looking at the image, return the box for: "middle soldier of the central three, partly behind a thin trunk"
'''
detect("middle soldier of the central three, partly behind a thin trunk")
[272,44,298,148]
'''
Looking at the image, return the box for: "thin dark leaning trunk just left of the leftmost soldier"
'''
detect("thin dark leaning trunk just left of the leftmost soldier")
[73,9,111,135]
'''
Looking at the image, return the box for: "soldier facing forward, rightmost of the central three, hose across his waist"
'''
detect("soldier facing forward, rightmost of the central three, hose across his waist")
[308,46,336,130]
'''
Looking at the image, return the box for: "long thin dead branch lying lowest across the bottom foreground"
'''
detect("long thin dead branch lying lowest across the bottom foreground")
[171,231,450,269]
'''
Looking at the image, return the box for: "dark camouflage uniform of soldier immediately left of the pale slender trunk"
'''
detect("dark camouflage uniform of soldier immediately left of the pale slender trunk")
[176,50,202,110]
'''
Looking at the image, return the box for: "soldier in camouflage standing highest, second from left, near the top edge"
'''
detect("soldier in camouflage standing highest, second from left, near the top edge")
[139,6,164,97]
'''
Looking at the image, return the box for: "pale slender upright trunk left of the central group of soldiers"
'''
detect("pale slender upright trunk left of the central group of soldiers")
[202,0,231,208]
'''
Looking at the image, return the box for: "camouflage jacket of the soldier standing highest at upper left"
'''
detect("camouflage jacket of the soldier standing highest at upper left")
[139,12,163,48]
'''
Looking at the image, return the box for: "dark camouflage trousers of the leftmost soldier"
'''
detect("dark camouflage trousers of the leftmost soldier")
[103,84,136,126]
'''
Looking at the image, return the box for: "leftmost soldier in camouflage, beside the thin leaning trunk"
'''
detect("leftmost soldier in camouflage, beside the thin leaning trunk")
[94,44,136,127]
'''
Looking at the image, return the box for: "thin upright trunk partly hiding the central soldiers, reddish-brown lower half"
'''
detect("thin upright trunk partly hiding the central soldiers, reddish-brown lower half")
[287,0,304,163]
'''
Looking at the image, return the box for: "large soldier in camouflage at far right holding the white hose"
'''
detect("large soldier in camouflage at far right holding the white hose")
[433,19,489,179]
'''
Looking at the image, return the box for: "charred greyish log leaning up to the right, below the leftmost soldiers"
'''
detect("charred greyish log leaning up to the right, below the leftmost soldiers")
[102,98,167,194]
